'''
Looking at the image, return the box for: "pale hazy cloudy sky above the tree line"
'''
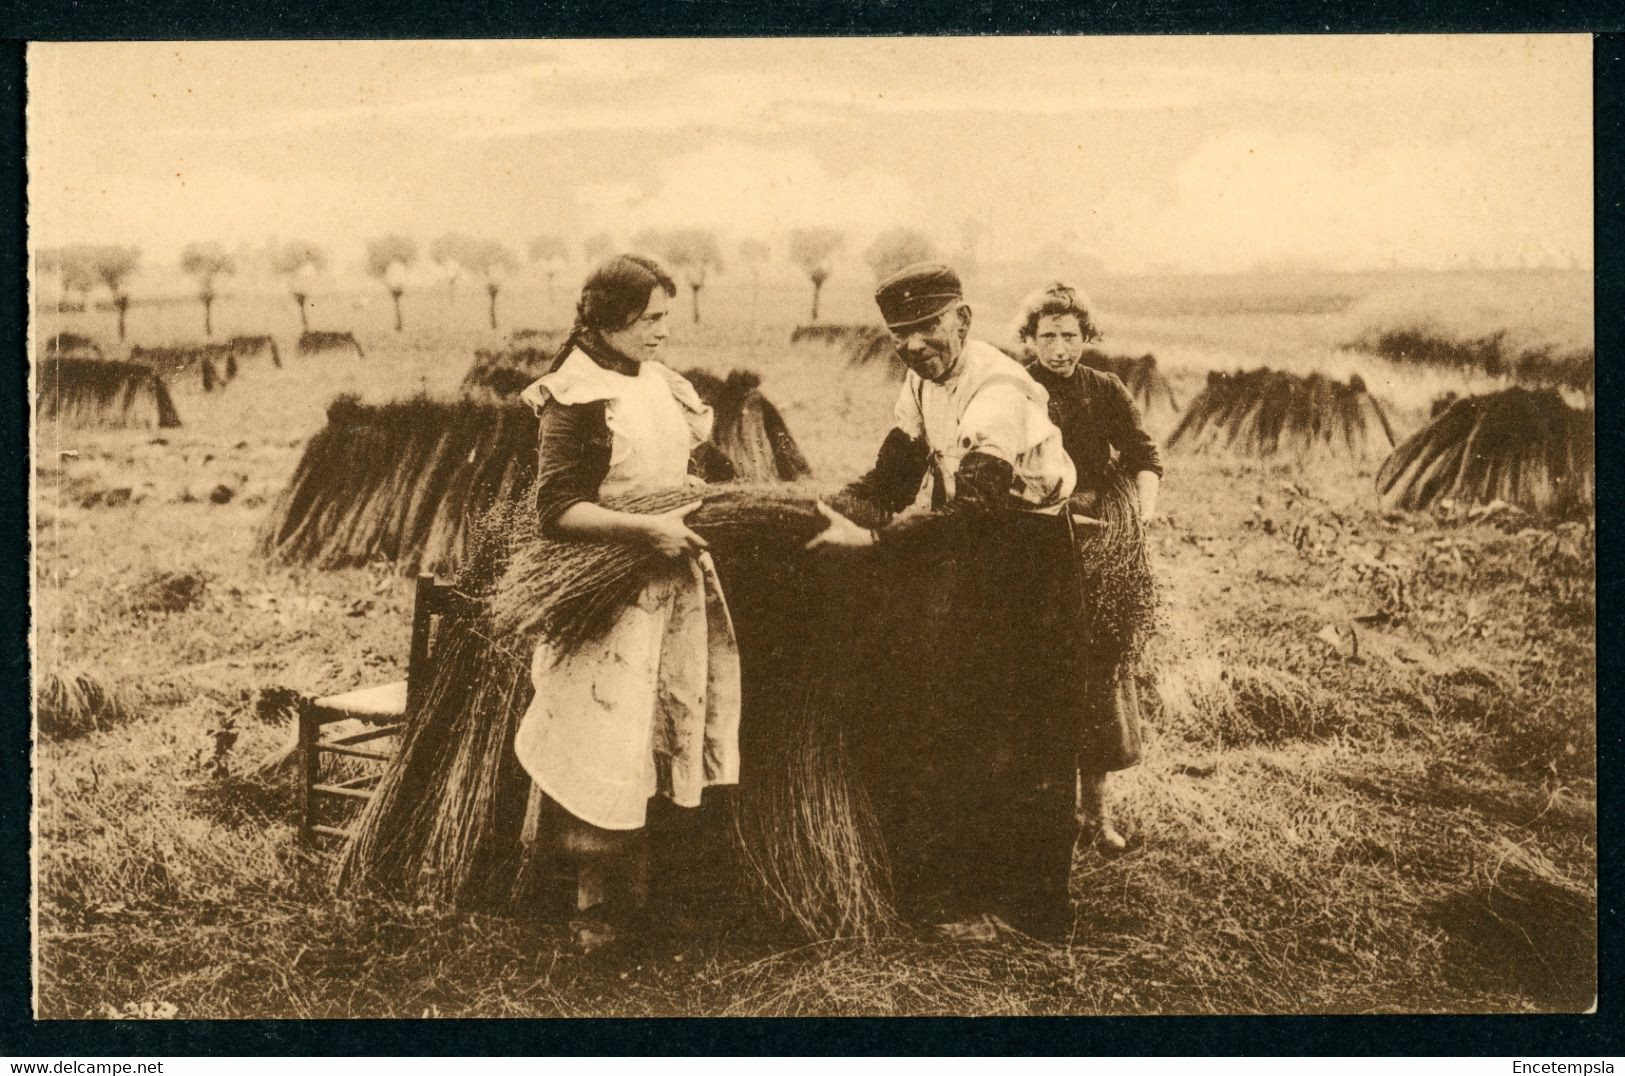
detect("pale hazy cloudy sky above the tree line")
[28,36,1593,282]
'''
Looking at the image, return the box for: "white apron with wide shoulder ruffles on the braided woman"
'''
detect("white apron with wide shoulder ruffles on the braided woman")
[514,351,739,839]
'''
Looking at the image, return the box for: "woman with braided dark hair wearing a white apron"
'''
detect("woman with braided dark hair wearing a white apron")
[514,255,739,949]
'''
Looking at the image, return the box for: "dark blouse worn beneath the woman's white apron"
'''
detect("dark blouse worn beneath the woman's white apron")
[536,349,733,533]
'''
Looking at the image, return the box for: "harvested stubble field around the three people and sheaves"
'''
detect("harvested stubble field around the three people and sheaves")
[34,271,1597,1019]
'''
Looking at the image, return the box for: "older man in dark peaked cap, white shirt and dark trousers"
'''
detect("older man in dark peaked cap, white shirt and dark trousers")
[811,263,1077,936]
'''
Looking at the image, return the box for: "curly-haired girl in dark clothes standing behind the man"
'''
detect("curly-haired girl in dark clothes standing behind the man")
[1017,281,1162,852]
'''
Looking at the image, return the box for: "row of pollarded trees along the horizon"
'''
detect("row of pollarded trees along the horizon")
[39,228,938,341]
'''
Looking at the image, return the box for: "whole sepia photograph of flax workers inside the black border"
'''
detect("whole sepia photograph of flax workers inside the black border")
[26,34,1599,1027]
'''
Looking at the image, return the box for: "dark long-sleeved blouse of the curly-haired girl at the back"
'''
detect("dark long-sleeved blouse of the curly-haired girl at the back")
[1027,362,1162,489]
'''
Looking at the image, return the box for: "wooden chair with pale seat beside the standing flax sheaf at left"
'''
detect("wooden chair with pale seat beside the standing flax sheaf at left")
[297,574,473,844]
